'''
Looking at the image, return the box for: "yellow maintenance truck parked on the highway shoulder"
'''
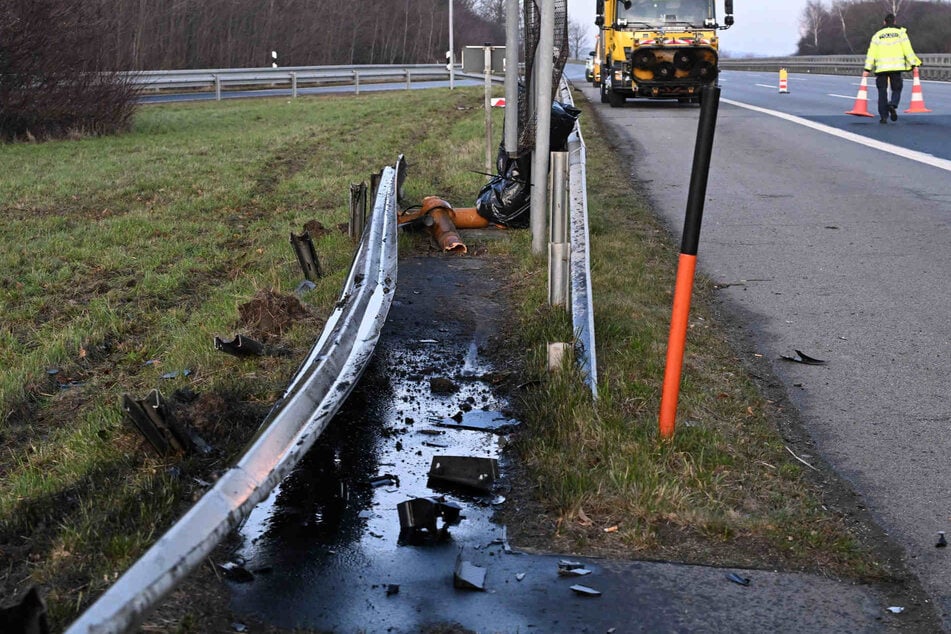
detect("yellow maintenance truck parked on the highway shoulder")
[595,0,733,108]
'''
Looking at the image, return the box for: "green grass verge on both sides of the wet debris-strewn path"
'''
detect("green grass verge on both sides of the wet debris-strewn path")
[0,82,876,629]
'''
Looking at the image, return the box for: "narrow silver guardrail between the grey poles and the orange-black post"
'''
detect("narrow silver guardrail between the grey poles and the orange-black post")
[561,81,598,399]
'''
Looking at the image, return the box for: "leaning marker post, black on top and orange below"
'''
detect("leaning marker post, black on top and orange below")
[660,86,720,439]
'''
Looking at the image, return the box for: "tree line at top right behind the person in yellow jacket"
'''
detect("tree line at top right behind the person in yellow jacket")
[797,0,951,55]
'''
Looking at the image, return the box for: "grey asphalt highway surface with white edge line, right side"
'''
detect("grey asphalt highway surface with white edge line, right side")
[575,72,951,630]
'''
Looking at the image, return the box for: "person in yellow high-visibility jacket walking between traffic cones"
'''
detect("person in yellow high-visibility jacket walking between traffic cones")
[865,13,921,123]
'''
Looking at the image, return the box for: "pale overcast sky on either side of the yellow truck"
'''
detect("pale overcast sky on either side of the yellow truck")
[568,0,806,56]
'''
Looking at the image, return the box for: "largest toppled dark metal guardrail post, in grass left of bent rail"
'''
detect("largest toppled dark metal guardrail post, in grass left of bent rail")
[122,390,211,456]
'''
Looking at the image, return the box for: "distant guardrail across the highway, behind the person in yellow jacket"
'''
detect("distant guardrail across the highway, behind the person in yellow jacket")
[720,54,951,81]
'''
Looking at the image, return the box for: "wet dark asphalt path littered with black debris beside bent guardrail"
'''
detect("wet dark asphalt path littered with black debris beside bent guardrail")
[218,249,928,633]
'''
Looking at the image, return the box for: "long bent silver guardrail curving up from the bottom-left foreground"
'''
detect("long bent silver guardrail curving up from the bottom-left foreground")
[67,158,397,634]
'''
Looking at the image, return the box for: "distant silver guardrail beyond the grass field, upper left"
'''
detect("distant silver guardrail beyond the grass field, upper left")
[122,64,498,99]
